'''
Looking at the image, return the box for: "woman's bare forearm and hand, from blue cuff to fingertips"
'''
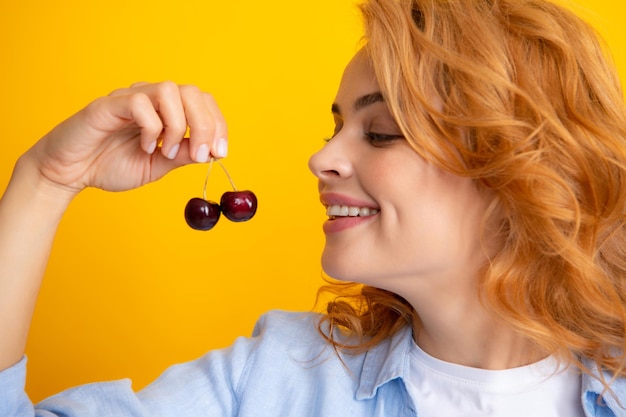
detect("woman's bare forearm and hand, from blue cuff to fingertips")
[0,82,226,370]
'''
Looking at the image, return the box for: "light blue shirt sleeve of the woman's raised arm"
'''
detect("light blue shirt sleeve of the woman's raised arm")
[0,332,256,417]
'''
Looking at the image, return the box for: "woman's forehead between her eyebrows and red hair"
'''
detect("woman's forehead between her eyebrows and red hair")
[335,50,380,109]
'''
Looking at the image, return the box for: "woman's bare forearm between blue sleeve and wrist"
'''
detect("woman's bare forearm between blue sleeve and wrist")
[0,155,73,369]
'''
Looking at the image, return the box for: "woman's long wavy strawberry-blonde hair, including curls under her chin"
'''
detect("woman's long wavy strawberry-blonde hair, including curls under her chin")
[322,0,626,388]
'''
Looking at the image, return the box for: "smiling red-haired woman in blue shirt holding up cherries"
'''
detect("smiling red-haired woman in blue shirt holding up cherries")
[0,0,626,416]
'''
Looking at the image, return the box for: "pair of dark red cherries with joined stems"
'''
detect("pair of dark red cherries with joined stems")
[185,159,257,230]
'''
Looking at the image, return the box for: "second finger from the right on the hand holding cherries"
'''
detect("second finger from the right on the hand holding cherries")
[180,85,216,162]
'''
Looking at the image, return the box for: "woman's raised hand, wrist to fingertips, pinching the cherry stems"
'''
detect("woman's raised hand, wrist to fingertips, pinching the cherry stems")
[25,82,227,194]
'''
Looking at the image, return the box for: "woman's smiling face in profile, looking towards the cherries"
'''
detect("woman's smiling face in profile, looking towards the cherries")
[309,51,487,295]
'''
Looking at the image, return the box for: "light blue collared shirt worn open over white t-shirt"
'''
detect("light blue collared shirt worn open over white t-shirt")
[0,311,626,417]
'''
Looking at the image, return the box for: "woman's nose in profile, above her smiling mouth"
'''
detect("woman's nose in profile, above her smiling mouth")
[309,136,354,182]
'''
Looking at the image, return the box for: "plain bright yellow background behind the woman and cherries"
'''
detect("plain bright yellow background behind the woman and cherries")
[0,0,626,400]
